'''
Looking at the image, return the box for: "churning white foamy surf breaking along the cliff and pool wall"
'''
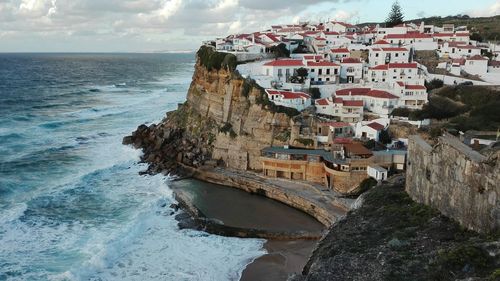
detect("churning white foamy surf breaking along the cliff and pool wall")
[0,55,264,281]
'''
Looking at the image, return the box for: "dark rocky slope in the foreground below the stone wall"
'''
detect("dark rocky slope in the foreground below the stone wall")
[289,184,500,281]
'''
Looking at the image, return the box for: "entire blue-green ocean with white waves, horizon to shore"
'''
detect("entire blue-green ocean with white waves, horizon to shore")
[0,54,264,281]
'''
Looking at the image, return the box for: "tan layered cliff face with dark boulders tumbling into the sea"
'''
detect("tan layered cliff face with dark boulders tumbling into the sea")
[123,50,293,173]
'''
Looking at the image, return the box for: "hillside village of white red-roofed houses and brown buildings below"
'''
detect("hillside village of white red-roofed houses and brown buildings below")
[204,16,500,194]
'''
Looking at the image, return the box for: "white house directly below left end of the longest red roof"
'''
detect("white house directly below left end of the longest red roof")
[315,97,363,123]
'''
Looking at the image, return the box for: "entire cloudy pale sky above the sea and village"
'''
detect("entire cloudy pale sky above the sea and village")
[0,0,500,52]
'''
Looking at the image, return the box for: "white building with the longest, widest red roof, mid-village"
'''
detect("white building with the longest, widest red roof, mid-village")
[335,88,399,116]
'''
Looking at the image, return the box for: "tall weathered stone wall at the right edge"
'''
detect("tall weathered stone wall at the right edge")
[406,135,500,233]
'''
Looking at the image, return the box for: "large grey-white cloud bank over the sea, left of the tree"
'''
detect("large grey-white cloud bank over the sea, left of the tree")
[0,0,366,49]
